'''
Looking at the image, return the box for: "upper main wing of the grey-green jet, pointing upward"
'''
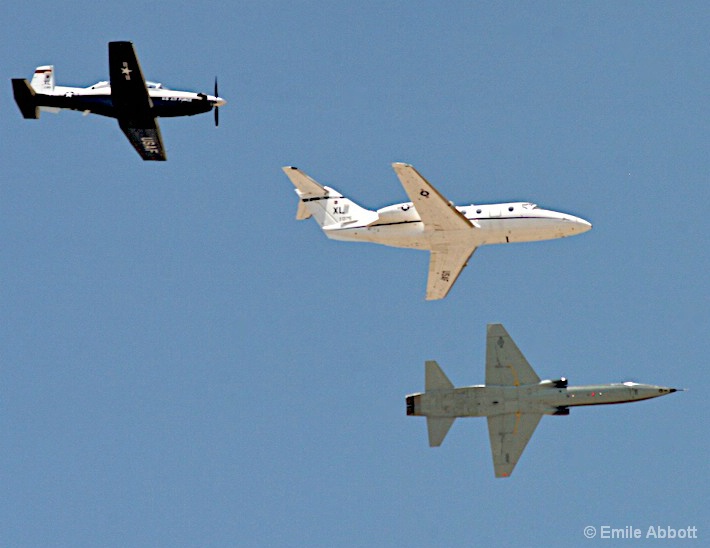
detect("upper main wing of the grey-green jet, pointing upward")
[486,323,540,386]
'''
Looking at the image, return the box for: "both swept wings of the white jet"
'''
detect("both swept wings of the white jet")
[392,163,477,301]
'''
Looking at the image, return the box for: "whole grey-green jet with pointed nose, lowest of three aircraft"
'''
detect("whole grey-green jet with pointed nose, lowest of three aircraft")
[407,324,677,478]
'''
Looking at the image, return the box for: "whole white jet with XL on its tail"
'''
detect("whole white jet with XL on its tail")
[283,163,592,300]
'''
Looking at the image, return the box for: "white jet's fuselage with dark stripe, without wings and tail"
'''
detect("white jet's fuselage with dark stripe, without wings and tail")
[324,202,592,249]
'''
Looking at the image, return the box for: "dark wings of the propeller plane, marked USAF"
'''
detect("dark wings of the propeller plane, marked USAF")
[108,42,167,161]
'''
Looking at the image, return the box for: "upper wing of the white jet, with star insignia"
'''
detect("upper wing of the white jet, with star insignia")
[392,163,473,230]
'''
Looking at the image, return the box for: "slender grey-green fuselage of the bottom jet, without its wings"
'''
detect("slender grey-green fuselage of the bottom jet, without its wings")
[408,381,676,417]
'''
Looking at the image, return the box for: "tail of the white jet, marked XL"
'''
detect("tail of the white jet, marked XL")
[283,166,379,230]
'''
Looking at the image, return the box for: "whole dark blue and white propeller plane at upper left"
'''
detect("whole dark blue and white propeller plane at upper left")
[12,42,226,160]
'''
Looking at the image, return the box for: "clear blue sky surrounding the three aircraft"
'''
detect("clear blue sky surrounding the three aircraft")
[0,0,710,547]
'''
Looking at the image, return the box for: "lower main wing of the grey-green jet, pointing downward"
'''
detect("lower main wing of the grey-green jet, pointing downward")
[488,413,542,478]
